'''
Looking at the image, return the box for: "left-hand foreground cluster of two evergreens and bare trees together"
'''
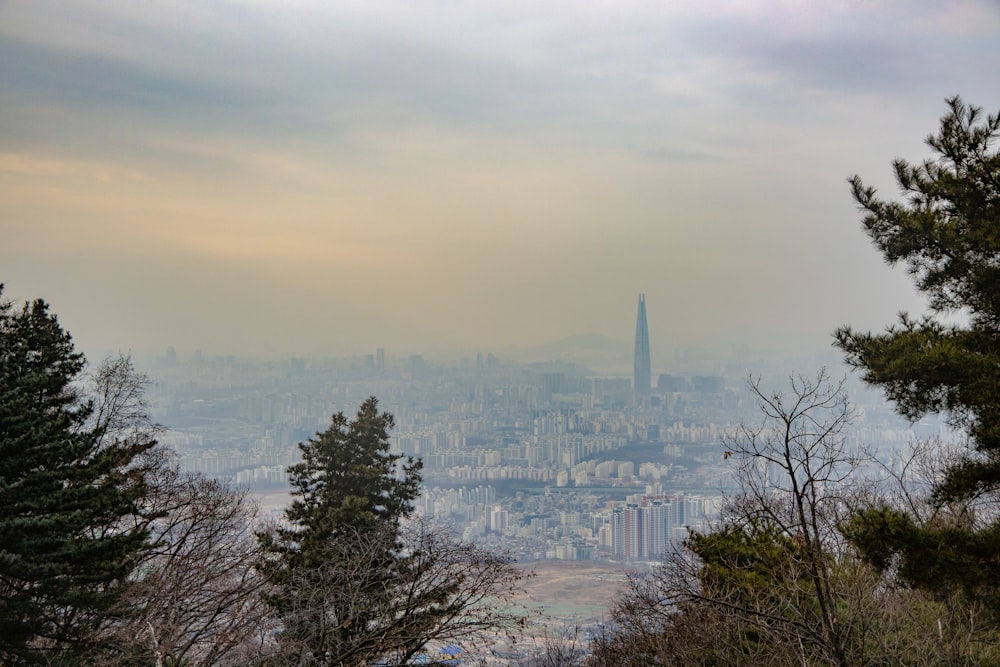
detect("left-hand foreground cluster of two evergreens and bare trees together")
[0,288,526,667]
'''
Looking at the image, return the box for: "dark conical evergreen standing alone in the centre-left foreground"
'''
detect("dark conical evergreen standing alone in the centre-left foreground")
[260,397,422,665]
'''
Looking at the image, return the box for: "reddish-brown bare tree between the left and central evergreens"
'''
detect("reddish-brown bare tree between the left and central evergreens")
[99,466,269,667]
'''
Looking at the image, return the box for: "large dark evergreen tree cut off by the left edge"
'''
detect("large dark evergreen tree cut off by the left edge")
[0,286,154,664]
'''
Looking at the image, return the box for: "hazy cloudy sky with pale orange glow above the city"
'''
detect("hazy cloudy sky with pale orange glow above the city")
[0,0,1000,366]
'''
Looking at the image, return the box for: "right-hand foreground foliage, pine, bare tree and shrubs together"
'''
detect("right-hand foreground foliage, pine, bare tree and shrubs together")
[591,97,1000,667]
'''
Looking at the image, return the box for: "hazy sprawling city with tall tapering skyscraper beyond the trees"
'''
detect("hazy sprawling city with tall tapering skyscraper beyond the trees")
[151,294,928,562]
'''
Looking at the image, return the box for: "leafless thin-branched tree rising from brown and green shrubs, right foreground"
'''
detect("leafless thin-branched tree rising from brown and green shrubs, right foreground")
[594,371,926,666]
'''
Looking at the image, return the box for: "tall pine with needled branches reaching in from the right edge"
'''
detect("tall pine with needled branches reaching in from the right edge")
[836,97,1000,499]
